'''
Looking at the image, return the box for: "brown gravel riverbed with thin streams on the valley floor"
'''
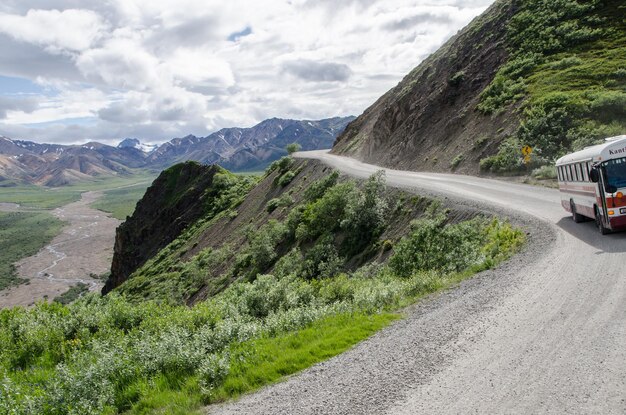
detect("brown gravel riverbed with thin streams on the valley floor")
[0,192,120,308]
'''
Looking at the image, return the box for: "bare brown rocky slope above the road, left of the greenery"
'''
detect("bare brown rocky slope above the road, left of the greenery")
[333,1,515,171]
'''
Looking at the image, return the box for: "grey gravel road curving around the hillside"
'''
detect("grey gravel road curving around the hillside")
[208,152,626,415]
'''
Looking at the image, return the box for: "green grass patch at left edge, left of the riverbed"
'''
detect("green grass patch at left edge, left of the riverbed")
[0,212,64,290]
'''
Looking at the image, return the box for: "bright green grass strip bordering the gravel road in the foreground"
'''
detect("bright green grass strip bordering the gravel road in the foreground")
[127,313,401,415]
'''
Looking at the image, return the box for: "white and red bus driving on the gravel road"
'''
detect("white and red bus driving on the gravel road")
[556,135,626,235]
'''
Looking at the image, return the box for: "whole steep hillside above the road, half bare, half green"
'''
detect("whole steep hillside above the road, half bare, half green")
[333,0,626,173]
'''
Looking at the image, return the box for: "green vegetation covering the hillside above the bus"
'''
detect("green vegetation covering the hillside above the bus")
[478,0,626,177]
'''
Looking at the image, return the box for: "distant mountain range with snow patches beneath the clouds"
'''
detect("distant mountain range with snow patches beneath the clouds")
[0,117,354,186]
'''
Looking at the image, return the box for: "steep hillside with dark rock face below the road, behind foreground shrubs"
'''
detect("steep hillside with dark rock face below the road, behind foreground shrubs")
[105,158,494,303]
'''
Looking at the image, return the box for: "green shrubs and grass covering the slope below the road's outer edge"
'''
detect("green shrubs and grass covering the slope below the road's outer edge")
[0,159,524,414]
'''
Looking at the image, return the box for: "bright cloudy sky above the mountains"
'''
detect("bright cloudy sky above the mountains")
[0,0,493,144]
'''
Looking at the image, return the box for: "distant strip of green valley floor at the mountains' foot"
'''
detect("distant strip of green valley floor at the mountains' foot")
[0,171,154,209]
